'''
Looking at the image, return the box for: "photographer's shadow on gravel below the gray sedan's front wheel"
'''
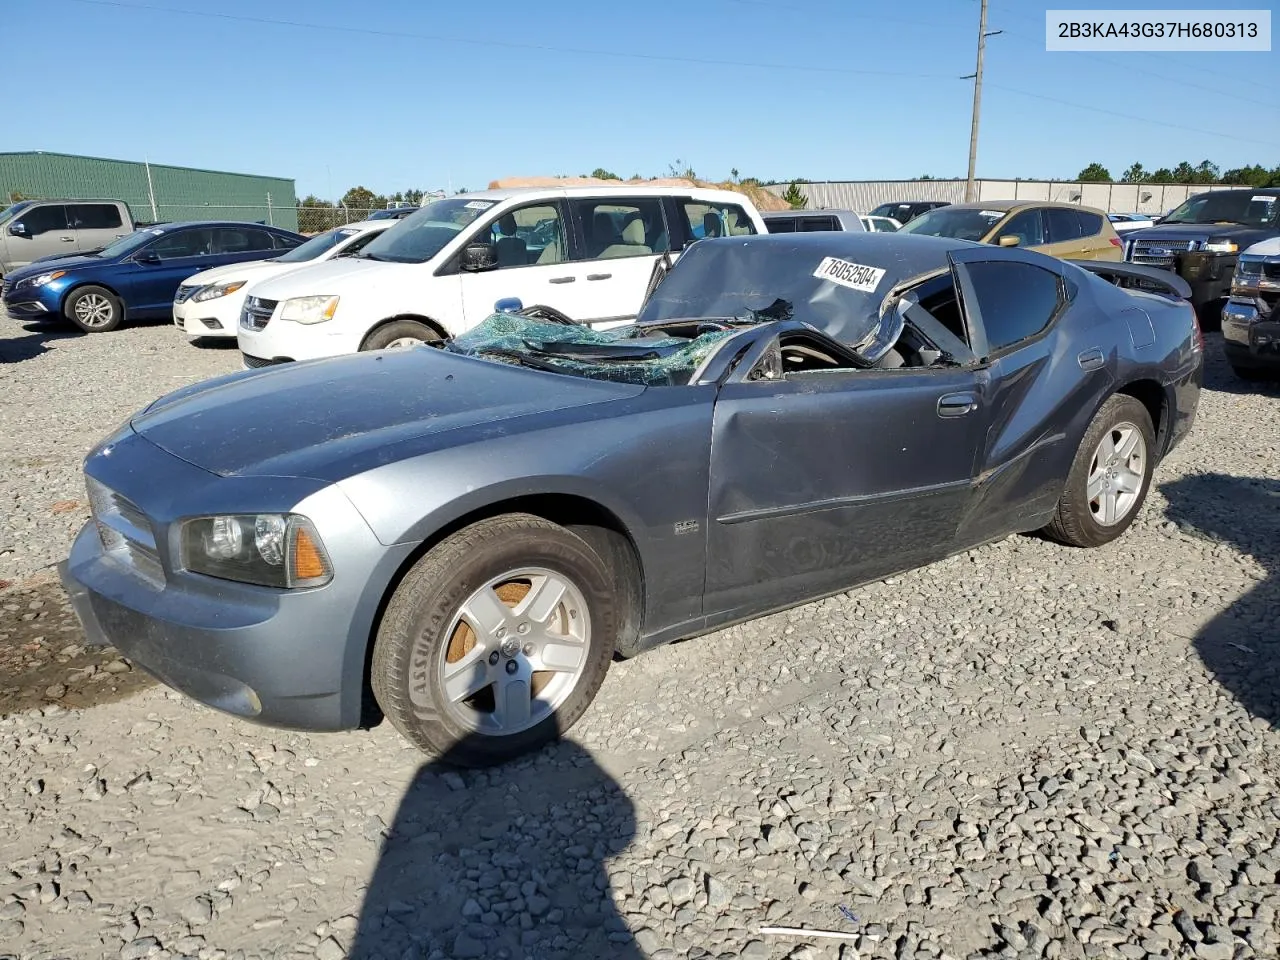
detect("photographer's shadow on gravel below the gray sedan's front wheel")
[348,740,644,960]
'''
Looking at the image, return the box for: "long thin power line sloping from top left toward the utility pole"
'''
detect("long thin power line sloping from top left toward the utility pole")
[60,0,950,79]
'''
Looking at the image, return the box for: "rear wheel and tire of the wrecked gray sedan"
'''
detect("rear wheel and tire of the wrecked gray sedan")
[1044,394,1156,547]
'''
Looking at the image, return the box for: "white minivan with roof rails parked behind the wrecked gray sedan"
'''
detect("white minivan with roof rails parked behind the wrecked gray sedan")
[238,186,765,367]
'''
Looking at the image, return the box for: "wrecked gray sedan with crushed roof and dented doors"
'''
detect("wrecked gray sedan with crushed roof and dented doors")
[63,233,1202,764]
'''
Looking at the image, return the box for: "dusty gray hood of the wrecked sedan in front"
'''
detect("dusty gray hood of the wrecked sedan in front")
[132,347,645,483]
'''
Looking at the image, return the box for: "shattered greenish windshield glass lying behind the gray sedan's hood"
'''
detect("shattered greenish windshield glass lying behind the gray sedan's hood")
[445,314,736,387]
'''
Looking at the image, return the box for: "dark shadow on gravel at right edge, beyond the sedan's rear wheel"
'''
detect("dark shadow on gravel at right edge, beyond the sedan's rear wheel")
[1160,474,1280,727]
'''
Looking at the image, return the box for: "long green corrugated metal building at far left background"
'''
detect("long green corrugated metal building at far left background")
[0,151,298,230]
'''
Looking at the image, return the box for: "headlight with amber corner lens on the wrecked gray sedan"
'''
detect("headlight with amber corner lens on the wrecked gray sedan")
[182,513,333,589]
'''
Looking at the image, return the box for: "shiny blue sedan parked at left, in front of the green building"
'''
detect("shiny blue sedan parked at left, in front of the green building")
[4,220,306,333]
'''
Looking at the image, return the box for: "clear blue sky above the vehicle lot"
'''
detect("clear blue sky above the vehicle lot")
[0,0,1280,197]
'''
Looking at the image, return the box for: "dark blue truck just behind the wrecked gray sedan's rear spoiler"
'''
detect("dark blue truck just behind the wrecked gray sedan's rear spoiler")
[1124,187,1280,320]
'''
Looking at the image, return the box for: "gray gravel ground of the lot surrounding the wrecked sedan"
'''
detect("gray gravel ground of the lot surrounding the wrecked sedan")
[0,321,1280,960]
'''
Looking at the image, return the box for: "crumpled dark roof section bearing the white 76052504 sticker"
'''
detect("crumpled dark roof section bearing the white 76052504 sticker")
[636,234,895,348]
